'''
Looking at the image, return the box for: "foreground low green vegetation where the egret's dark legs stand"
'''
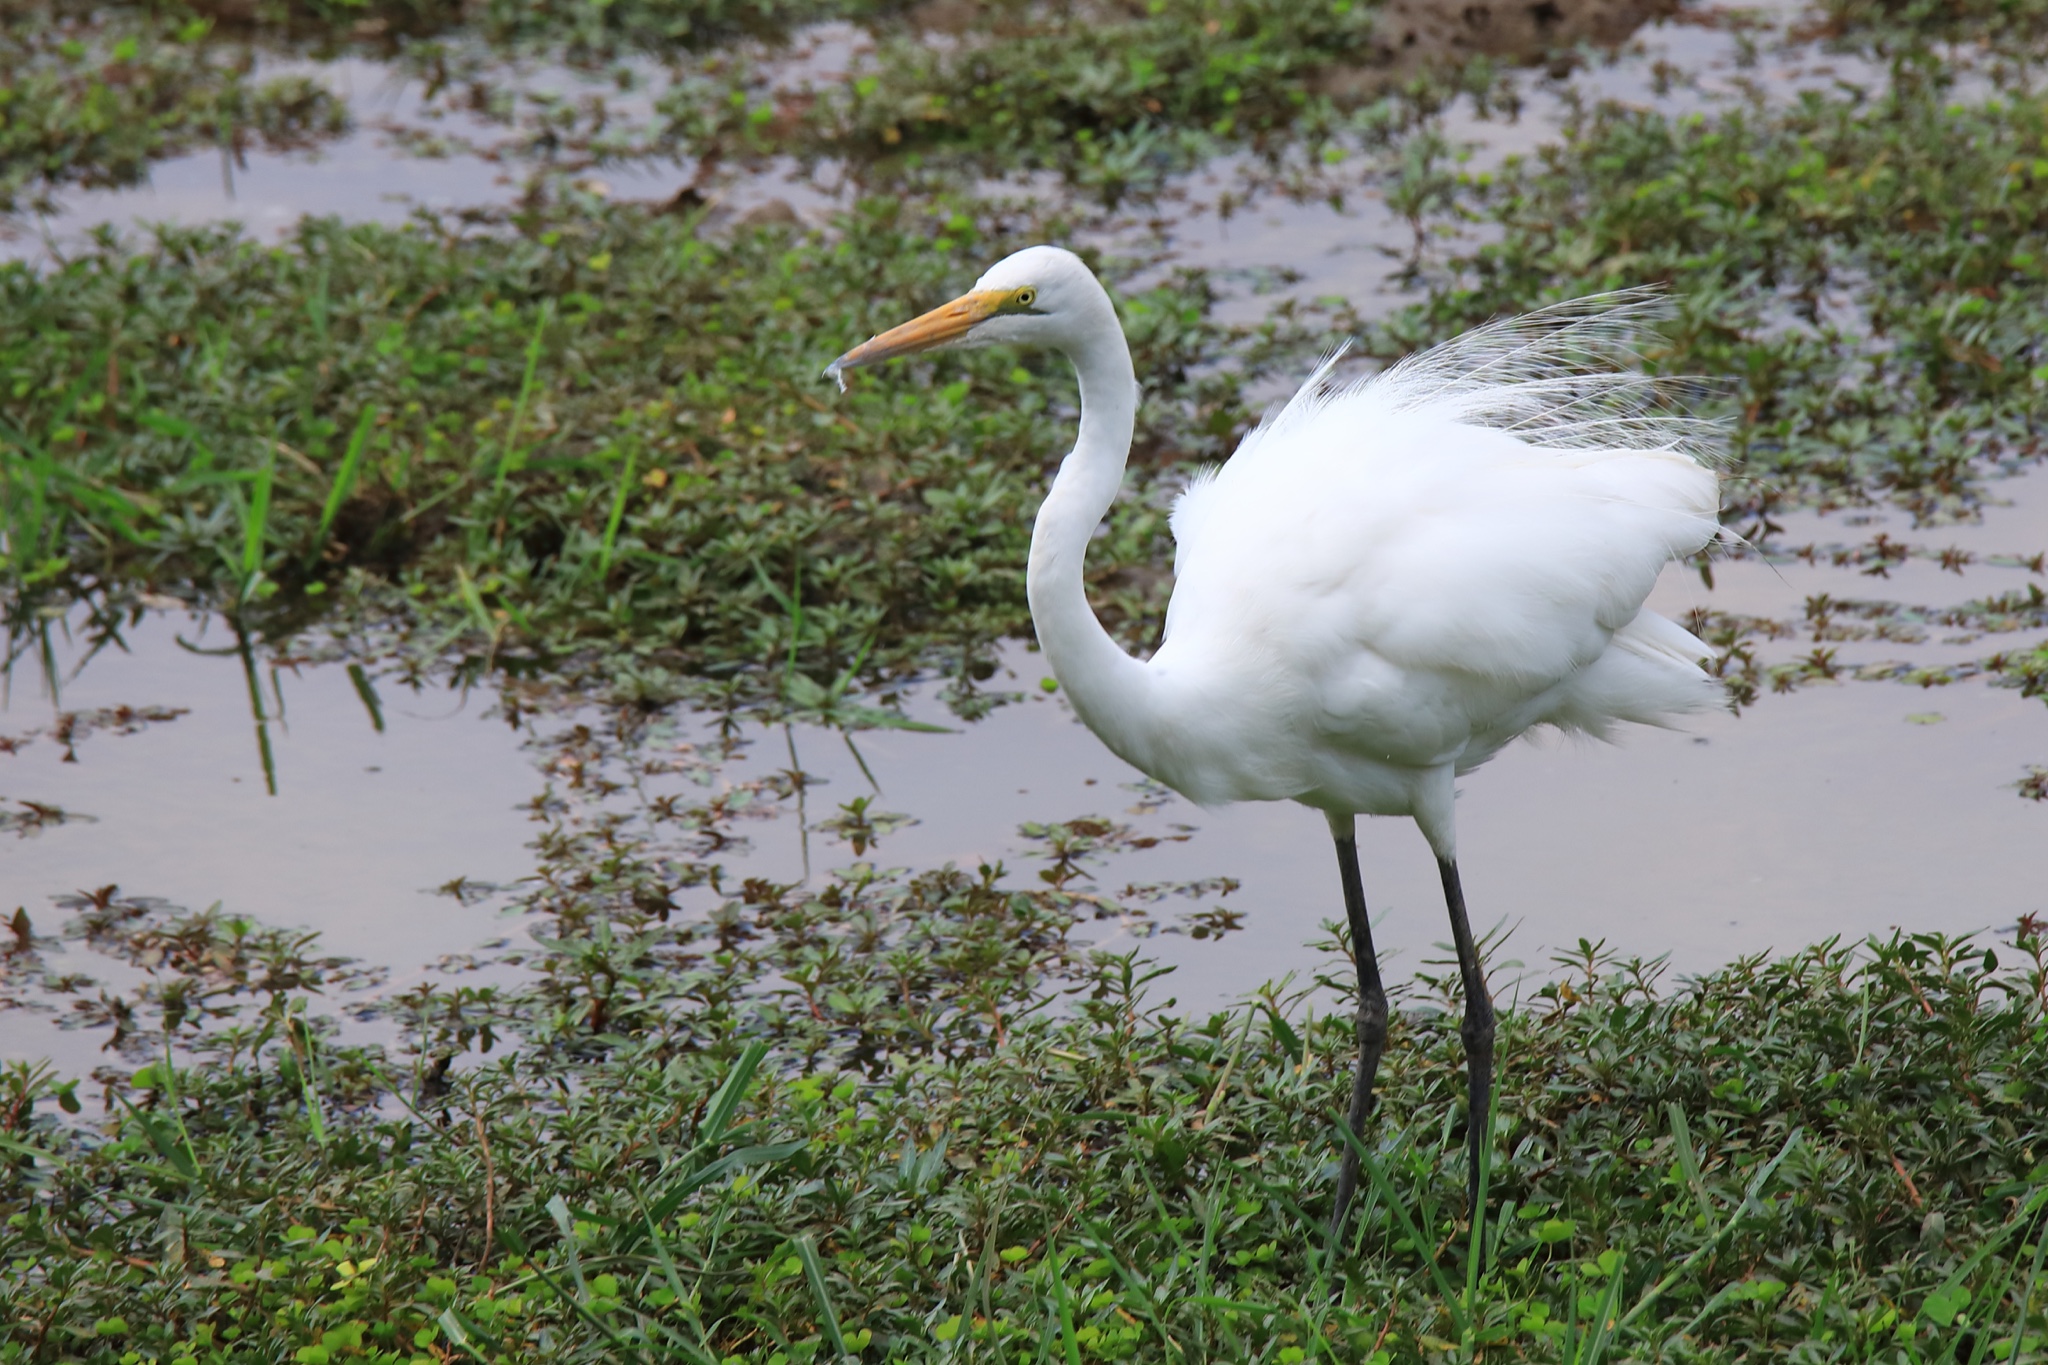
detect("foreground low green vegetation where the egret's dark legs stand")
[0,706,2048,1365]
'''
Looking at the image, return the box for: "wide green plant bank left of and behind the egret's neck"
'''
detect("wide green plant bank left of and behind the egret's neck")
[0,201,1241,699]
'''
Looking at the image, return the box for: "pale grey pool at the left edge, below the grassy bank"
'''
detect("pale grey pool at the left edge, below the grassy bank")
[0,614,539,1072]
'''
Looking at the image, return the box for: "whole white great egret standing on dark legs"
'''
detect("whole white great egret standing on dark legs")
[825,246,1722,1234]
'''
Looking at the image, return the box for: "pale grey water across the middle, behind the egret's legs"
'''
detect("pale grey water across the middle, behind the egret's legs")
[12,458,2048,1064]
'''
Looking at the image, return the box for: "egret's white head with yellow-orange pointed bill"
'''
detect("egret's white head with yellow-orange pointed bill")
[825,246,1116,389]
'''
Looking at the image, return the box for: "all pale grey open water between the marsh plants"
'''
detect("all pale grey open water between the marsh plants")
[0,5,2048,1070]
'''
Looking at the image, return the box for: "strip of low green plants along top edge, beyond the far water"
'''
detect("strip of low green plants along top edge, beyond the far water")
[0,0,1495,211]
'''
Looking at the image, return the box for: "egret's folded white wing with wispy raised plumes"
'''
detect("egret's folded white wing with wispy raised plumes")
[1161,291,1720,749]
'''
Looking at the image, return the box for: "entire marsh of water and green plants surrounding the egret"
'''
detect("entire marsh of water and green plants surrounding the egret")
[0,0,2048,1365]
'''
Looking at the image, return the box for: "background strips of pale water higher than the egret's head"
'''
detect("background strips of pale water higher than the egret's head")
[0,0,1882,323]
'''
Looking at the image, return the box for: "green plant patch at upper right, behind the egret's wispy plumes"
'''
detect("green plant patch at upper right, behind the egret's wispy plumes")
[1384,55,2048,534]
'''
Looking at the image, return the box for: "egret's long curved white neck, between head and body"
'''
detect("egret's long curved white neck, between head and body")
[1024,317,1149,759]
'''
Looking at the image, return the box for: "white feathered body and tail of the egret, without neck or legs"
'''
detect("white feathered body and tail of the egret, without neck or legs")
[1139,295,1720,834]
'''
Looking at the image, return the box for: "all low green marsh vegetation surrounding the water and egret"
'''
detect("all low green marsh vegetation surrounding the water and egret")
[0,0,2048,1365]
